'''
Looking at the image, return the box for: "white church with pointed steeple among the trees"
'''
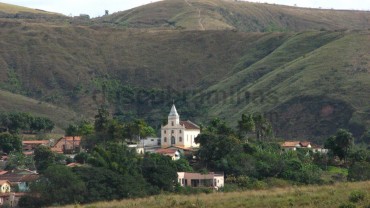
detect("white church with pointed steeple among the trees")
[161,105,200,148]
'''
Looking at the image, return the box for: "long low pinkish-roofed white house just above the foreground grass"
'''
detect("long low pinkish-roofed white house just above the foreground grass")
[177,172,225,189]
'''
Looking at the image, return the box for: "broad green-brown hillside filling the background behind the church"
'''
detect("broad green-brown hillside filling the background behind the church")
[0,0,370,139]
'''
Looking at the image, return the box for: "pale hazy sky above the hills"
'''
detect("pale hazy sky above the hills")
[0,0,370,17]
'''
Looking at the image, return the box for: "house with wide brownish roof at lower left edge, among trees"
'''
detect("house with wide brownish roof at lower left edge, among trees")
[0,170,39,192]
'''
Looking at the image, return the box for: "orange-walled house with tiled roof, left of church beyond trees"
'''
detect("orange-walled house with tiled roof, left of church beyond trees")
[51,136,81,154]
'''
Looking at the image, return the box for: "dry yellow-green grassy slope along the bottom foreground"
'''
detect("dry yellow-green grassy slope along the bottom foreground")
[55,182,370,208]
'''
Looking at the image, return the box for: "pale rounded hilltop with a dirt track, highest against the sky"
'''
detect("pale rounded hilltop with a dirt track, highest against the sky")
[95,0,370,32]
